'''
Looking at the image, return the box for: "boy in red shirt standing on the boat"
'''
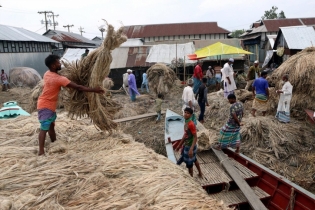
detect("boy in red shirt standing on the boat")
[176,107,202,177]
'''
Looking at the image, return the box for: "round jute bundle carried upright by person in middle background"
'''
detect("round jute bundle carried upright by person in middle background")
[147,63,176,95]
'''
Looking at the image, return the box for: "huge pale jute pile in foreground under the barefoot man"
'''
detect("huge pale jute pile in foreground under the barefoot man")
[0,113,227,210]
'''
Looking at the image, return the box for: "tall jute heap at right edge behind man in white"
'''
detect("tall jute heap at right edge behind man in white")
[271,47,315,116]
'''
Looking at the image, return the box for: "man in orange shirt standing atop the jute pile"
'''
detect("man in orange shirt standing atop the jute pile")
[37,55,104,155]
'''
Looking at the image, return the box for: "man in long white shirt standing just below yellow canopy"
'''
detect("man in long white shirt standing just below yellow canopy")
[221,58,236,98]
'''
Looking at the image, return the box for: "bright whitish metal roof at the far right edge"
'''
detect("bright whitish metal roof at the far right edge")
[279,26,315,50]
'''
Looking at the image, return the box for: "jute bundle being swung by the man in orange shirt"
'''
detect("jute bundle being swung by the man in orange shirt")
[60,24,127,131]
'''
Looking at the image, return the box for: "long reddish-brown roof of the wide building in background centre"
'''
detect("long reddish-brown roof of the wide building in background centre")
[124,22,230,38]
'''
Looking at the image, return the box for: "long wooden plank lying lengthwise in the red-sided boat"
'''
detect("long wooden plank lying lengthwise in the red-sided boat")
[212,149,267,210]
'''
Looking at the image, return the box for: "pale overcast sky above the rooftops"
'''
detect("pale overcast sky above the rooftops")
[0,0,315,39]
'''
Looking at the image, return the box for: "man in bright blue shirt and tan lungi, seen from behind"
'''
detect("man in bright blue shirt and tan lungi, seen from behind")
[251,72,269,117]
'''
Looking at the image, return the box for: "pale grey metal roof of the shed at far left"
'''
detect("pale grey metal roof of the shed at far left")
[0,25,59,43]
